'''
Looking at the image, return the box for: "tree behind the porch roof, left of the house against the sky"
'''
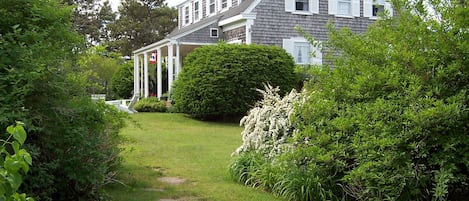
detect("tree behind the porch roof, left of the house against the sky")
[107,0,177,56]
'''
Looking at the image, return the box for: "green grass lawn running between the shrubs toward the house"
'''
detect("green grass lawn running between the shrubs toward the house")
[106,113,281,201]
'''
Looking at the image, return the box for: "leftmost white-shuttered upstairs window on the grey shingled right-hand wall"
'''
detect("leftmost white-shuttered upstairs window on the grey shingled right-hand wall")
[285,0,319,15]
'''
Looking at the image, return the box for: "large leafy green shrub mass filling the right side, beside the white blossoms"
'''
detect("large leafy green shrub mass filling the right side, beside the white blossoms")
[231,1,469,200]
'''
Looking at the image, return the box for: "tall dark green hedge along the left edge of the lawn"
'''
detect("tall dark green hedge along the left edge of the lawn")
[0,0,128,200]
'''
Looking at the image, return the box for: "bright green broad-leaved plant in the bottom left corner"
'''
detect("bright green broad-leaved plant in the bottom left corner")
[0,122,33,201]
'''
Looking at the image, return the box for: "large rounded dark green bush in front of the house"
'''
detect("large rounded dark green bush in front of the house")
[173,43,296,118]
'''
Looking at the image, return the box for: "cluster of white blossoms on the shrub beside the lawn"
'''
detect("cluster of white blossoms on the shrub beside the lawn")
[234,85,301,159]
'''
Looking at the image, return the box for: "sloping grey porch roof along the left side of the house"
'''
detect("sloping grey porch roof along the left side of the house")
[168,0,255,38]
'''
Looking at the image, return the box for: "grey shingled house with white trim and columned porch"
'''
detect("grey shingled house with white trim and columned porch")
[134,0,392,97]
